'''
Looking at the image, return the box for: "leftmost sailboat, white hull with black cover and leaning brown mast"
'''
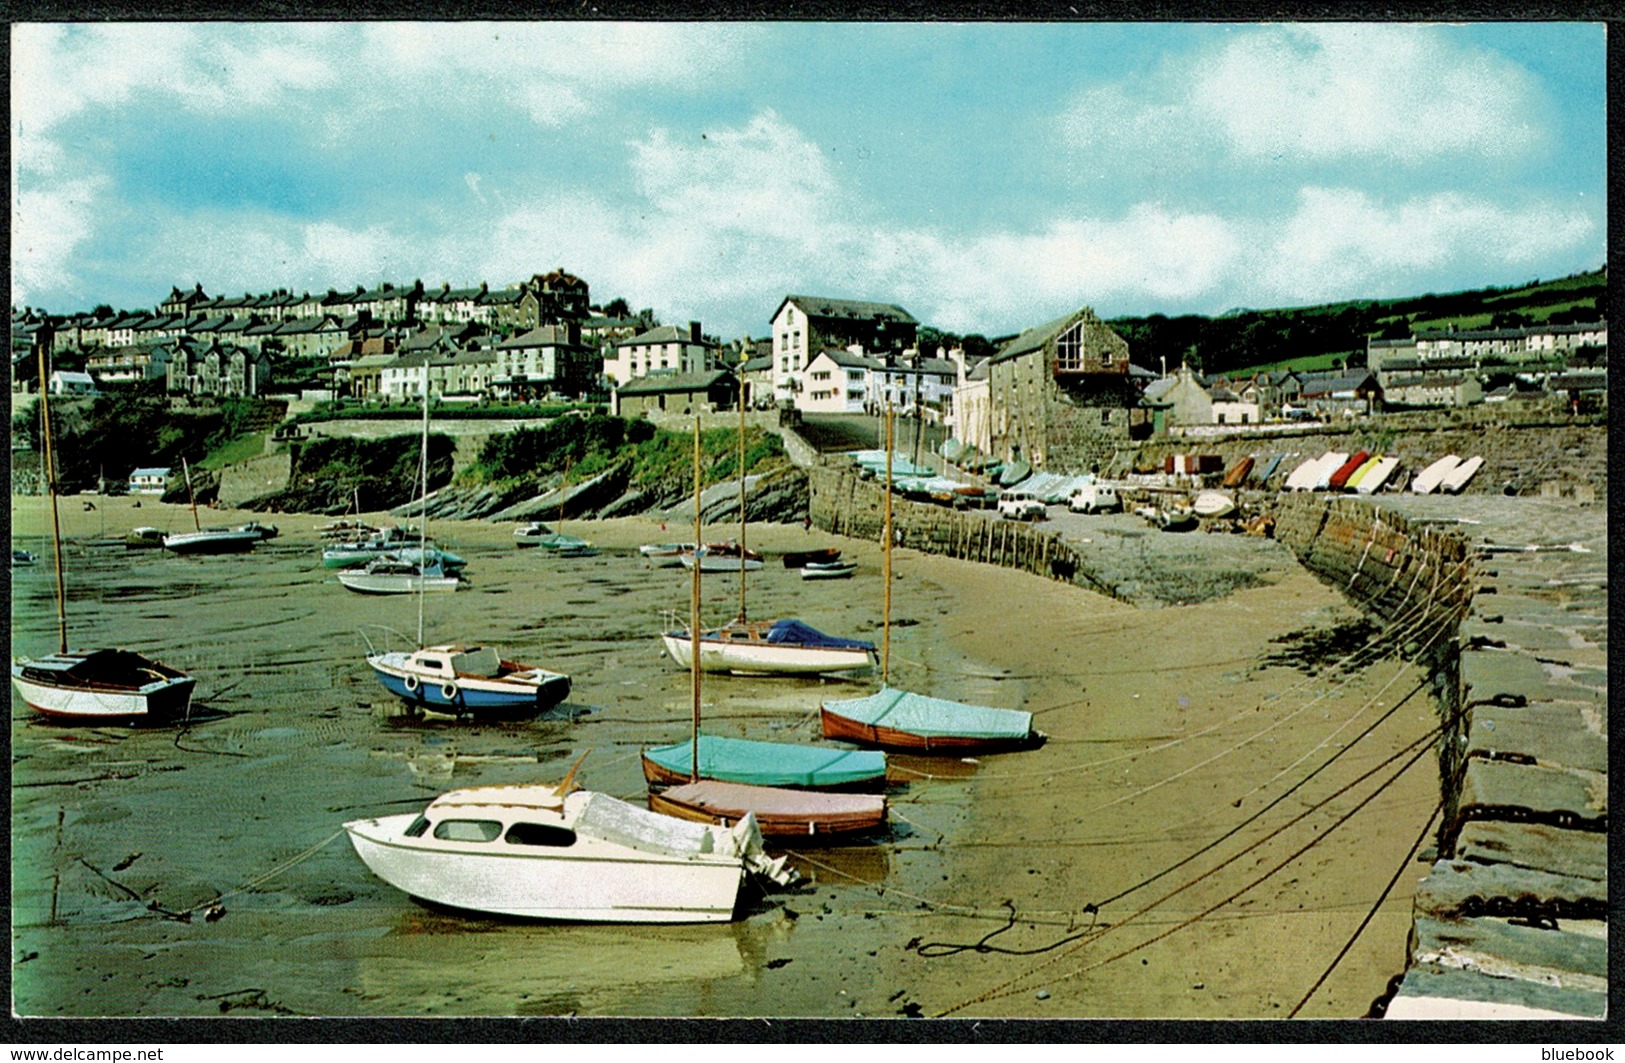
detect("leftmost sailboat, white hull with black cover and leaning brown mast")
[11,351,197,723]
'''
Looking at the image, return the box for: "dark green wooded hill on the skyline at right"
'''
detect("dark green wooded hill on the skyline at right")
[1108,268,1609,374]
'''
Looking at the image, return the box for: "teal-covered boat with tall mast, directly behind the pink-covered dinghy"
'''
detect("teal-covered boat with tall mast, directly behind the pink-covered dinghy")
[642,418,886,803]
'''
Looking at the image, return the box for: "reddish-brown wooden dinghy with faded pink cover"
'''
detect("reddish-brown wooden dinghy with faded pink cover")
[648,779,886,840]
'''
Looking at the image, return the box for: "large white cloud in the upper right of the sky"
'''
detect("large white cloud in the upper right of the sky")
[1061,23,1544,167]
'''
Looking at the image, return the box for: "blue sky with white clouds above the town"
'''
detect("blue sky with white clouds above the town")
[10,23,1607,340]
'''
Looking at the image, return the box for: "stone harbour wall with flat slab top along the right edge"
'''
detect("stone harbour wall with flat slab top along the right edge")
[1276,496,1607,1019]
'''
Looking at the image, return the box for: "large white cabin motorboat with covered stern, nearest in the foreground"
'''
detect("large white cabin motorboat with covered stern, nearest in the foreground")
[345,783,796,923]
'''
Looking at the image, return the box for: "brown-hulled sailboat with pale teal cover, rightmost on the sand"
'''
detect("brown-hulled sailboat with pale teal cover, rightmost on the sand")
[819,403,1045,754]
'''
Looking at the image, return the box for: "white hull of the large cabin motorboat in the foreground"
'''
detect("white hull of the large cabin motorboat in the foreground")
[345,809,744,923]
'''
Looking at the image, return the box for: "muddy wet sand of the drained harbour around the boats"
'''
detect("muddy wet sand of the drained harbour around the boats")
[11,497,1438,1017]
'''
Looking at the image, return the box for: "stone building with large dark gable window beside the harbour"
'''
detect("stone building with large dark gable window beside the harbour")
[988,307,1149,470]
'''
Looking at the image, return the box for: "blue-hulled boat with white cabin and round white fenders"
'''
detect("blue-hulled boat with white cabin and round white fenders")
[367,645,570,718]
